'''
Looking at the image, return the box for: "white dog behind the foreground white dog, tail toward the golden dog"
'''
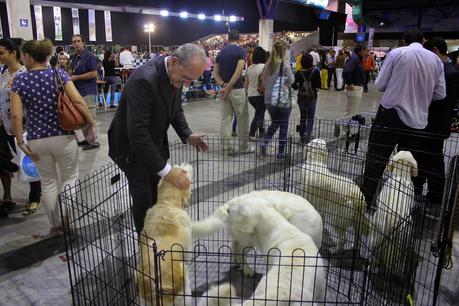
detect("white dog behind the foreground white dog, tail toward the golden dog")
[192,190,323,276]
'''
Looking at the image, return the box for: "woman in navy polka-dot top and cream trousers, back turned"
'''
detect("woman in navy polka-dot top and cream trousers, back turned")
[11,39,96,235]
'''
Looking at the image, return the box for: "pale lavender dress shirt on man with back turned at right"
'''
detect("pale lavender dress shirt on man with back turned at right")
[376,43,446,129]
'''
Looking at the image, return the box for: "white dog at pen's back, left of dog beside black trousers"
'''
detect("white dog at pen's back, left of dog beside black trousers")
[301,139,369,252]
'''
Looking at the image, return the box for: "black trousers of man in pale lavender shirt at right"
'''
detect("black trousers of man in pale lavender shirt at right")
[361,106,425,206]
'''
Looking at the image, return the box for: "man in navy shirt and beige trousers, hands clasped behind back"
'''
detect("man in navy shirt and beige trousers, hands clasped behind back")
[214,30,255,155]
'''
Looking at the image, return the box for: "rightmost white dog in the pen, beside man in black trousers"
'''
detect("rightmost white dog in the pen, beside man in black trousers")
[370,151,418,273]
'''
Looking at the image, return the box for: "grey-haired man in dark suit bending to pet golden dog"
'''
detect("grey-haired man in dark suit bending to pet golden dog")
[108,44,207,233]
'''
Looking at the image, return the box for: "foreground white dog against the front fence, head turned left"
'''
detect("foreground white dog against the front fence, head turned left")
[207,202,325,306]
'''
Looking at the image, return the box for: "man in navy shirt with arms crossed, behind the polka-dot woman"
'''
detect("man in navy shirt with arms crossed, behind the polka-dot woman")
[71,34,100,150]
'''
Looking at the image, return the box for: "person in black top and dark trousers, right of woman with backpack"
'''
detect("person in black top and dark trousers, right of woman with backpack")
[292,54,321,143]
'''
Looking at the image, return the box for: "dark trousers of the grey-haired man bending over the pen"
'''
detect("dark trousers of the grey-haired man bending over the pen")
[125,162,161,234]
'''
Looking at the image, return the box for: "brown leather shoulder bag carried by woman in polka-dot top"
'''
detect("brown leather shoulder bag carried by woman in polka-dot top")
[54,69,86,131]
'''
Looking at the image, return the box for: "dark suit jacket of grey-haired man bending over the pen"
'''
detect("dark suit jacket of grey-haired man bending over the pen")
[108,57,192,177]
